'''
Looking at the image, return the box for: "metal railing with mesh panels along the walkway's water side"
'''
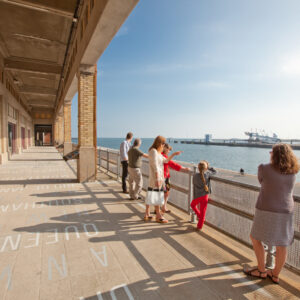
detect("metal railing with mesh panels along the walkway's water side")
[98,147,300,272]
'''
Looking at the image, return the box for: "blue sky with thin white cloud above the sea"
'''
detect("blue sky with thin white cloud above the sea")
[72,0,300,138]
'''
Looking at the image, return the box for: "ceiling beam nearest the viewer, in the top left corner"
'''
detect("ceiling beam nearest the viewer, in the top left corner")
[0,0,76,19]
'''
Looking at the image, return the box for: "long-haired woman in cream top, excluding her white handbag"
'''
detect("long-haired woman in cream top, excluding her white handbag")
[144,135,181,223]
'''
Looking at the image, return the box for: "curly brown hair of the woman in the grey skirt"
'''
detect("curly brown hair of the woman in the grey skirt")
[271,143,300,174]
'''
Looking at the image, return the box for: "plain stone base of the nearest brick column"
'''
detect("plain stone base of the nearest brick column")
[77,147,96,182]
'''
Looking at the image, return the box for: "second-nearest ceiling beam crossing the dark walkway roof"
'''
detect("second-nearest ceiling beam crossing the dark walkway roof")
[4,57,62,75]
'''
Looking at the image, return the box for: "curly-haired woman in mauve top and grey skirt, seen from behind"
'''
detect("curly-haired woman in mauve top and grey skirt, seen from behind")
[244,144,299,284]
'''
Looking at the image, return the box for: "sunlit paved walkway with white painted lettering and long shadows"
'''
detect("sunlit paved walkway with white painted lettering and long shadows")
[0,147,300,300]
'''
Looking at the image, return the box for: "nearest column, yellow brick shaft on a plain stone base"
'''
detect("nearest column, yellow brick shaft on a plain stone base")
[77,65,97,182]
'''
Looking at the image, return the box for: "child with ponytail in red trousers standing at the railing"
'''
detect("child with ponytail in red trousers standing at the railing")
[191,160,217,230]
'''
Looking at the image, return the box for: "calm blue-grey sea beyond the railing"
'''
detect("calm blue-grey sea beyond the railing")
[72,138,300,182]
